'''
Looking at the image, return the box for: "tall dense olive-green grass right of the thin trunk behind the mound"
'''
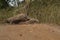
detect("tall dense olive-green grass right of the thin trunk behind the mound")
[29,0,60,24]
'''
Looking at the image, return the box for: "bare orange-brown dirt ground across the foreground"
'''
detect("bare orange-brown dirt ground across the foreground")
[0,24,60,40]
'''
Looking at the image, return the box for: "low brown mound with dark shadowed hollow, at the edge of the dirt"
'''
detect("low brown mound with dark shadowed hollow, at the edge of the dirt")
[5,14,39,24]
